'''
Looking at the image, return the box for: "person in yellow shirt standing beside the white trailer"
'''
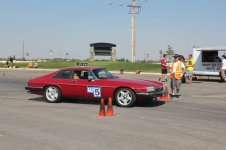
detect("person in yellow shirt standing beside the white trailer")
[186,54,195,84]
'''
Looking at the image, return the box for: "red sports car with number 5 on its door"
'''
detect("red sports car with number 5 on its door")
[25,66,165,107]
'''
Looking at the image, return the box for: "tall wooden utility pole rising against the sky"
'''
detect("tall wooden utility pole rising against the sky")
[127,0,141,63]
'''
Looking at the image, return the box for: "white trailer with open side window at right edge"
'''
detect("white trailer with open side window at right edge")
[193,47,226,80]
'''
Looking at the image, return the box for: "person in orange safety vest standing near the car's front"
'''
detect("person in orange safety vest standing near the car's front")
[170,54,185,96]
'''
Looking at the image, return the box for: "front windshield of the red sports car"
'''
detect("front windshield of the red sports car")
[93,68,116,79]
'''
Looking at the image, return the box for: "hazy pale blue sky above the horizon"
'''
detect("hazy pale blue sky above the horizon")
[0,0,226,60]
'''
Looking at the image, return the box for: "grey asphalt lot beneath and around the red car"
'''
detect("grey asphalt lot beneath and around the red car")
[0,69,226,150]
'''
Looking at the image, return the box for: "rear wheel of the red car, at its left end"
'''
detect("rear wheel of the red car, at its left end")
[44,86,62,103]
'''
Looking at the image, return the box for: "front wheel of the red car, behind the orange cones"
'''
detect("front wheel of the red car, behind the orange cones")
[115,88,136,107]
